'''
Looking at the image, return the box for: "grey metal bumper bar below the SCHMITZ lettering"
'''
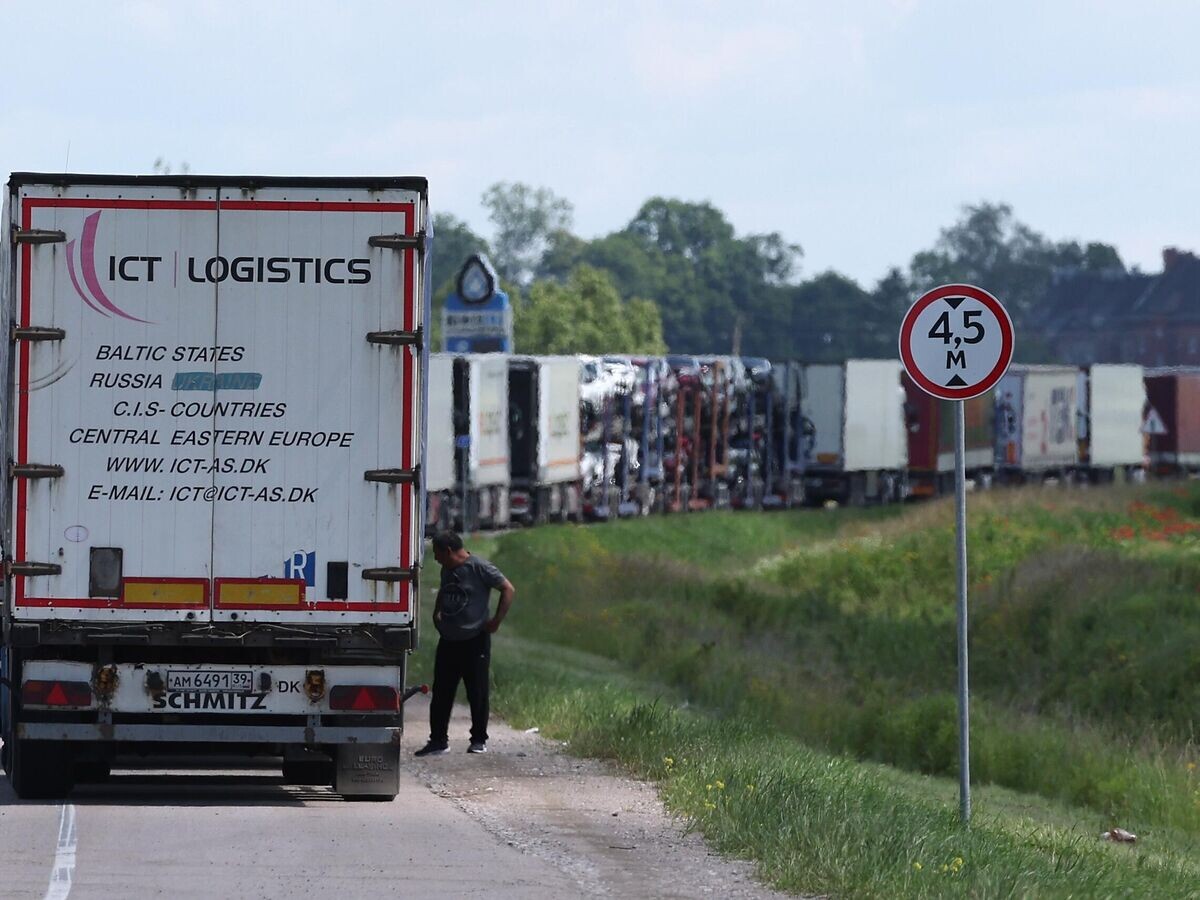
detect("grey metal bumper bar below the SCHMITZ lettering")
[17,722,404,746]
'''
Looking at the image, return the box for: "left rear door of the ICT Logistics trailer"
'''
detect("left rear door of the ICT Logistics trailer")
[10,184,217,622]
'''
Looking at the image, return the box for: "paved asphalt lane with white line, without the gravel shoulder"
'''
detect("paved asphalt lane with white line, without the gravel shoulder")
[0,770,578,900]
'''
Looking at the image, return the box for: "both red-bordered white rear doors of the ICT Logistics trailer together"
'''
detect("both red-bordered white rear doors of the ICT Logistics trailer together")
[11,180,425,624]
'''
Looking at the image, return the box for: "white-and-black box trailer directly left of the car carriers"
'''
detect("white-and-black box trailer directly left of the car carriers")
[509,356,582,524]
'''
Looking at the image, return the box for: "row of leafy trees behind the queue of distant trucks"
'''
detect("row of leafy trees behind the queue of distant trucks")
[434,188,1124,360]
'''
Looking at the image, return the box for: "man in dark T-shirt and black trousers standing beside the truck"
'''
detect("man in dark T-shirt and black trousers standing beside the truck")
[414,532,516,756]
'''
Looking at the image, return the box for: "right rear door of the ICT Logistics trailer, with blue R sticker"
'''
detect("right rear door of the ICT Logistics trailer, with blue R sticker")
[208,188,424,624]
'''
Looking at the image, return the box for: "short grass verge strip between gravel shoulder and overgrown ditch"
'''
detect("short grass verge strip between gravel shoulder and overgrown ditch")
[434,635,1200,898]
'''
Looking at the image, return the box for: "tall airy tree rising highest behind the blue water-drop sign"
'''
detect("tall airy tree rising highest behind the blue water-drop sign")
[481,181,575,286]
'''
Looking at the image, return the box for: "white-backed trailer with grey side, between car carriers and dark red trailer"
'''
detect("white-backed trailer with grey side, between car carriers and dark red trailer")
[803,360,908,504]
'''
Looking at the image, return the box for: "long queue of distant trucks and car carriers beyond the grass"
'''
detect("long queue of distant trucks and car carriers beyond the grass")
[425,354,1200,532]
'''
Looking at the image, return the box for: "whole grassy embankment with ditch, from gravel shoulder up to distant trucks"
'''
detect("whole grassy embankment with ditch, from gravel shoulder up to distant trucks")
[410,487,1200,896]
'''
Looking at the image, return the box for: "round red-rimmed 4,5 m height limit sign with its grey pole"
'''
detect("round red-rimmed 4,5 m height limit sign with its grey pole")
[900,284,1013,822]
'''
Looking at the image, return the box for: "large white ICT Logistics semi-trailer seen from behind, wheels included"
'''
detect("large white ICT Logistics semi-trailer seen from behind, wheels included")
[0,174,427,797]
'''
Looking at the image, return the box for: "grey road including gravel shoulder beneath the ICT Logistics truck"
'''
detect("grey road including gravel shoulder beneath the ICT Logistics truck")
[0,703,796,900]
